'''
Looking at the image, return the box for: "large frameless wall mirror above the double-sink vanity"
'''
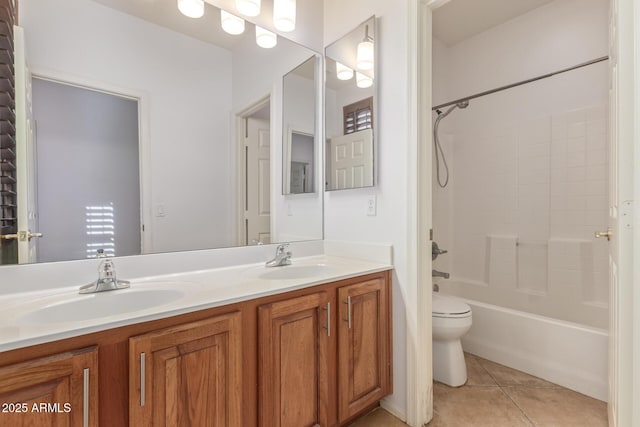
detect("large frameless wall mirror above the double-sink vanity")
[3,0,323,263]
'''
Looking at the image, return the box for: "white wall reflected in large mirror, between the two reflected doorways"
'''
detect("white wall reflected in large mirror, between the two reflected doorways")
[20,0,234,252]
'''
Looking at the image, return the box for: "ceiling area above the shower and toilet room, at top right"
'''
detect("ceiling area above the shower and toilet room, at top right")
[433,0,553,46]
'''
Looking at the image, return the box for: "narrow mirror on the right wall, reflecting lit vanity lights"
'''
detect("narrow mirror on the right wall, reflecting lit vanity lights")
[325,17,377,190]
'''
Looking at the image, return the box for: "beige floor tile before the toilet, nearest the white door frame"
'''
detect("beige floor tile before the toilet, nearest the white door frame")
[428,383,532,427]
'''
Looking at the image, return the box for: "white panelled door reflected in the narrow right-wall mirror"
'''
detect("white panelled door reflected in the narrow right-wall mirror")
[329,129,373,190]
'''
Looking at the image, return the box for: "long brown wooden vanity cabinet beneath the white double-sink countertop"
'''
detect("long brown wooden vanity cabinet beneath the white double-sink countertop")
[0,271,392,427]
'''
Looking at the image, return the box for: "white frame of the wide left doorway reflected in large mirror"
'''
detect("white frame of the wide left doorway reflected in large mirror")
[31,66,153,255]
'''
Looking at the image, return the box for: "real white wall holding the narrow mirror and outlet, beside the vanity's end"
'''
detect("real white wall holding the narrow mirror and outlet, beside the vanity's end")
[324,0,416,417]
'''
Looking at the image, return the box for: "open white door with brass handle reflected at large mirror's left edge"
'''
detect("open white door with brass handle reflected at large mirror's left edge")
[14,27,40,264]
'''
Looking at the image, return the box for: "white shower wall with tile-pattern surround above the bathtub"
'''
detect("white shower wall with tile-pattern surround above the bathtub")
[434,0,608,328]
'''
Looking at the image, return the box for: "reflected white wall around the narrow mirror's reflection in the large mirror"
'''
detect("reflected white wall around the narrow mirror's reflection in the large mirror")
[233,34,323,242]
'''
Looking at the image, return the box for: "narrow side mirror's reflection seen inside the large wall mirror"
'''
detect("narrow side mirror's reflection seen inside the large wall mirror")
[282,57,317,194]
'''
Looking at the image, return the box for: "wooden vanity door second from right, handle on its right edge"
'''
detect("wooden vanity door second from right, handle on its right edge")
[258,292,330,427]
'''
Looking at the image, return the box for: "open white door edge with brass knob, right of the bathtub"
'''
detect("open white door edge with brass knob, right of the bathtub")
[601,0,640,427]
